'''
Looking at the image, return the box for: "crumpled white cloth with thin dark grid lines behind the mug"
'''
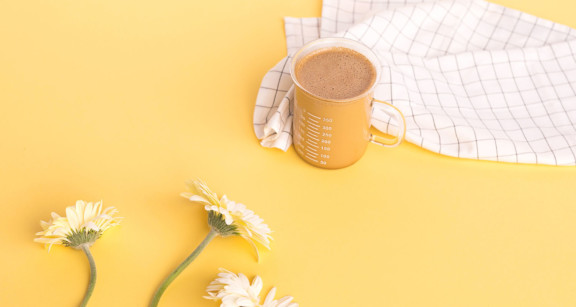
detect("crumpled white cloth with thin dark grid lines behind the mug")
[254,0,576,165]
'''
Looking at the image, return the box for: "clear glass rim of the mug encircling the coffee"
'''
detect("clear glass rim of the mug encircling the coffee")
[290,37,382,103]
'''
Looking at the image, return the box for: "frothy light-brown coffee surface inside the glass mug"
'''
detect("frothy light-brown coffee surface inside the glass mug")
[295,47,376,99]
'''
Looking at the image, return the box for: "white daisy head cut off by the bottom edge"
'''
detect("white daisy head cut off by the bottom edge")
[204,268,298,307]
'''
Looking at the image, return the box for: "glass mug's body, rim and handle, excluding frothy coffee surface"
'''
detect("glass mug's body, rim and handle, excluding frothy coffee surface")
[290,38,406,169]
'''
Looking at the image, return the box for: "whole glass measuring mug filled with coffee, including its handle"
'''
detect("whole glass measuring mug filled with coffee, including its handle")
[290,38,406,169]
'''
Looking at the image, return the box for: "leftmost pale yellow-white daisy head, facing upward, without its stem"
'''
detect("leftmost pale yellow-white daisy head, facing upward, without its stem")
[34,200,122,250]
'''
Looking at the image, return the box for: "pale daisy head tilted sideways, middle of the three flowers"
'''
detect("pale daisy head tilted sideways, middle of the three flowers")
[180,180,272,262]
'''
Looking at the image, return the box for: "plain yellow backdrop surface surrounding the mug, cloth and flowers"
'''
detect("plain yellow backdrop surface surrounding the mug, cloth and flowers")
[0,0,576,307]
